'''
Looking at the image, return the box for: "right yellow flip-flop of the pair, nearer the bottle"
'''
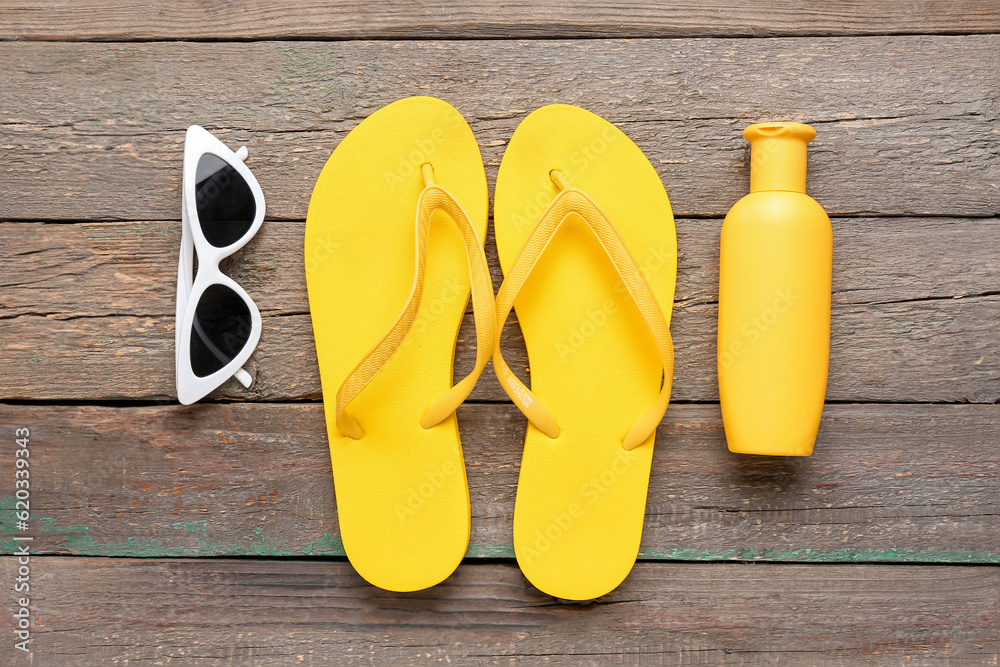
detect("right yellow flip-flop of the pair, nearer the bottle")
[493,104,677,600]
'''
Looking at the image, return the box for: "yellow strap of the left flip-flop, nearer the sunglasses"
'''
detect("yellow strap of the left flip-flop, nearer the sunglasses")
[336,164,498,440]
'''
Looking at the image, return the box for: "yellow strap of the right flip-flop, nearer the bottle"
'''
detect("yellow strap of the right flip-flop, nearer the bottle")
[493,170,674,450]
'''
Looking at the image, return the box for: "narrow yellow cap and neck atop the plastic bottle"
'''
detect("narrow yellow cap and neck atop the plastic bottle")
[743,123,816,194]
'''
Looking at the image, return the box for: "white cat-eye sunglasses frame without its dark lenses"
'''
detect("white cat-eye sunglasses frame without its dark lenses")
[174,125,264,405]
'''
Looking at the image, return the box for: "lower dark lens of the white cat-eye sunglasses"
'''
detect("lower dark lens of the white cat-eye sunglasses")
[191,285,251,377]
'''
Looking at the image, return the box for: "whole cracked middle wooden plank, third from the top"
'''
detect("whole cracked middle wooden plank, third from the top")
[7,217,1000,403]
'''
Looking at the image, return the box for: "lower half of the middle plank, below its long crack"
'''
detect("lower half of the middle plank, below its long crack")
[0,293,1000,403]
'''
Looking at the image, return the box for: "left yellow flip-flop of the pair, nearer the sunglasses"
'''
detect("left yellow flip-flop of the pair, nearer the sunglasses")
[305,97,497,591]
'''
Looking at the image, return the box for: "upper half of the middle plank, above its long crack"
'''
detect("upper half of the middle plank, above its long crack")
[9,217,1000,319]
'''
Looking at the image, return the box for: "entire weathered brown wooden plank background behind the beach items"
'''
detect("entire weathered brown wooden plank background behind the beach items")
[0,0,1000,665]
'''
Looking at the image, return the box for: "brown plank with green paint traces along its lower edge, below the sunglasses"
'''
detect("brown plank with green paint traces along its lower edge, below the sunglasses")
[0,404,1000,563]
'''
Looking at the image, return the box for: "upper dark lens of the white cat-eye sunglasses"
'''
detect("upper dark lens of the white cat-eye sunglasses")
[194,153,257,248]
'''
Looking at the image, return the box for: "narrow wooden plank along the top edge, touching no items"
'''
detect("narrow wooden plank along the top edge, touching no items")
[0,0,1000,41]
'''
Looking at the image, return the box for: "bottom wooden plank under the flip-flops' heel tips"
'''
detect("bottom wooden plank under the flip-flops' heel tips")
[0,557,1000,667]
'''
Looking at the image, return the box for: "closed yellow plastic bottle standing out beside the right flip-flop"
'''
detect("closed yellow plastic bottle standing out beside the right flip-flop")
[718,123,833,456]
